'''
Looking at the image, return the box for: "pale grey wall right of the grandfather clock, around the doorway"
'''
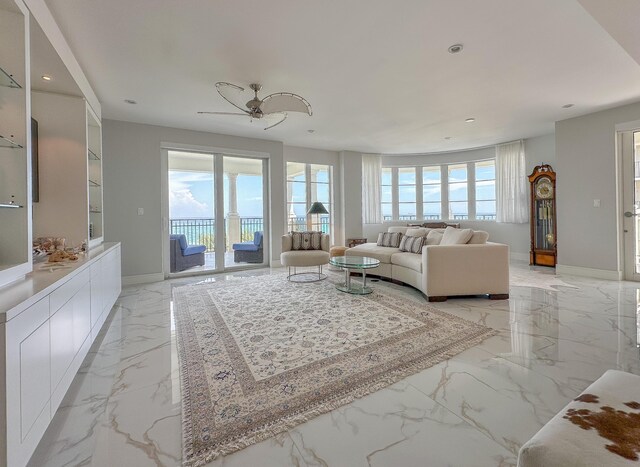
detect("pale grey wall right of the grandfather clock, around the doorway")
[556,99,640,277]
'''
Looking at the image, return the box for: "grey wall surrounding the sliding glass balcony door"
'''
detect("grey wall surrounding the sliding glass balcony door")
[102,120,285,282]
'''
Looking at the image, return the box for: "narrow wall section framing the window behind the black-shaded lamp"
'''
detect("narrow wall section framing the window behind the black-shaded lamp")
[284,146,344,245]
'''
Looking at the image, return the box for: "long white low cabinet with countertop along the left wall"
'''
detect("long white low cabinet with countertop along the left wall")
[0,243,121,467]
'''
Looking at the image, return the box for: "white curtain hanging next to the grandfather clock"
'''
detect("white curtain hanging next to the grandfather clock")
[496,140,529,224]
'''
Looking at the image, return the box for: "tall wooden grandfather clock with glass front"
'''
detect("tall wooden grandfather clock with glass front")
[529,164,557,267]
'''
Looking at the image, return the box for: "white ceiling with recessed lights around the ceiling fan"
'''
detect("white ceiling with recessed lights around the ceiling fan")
[47,0,640,153]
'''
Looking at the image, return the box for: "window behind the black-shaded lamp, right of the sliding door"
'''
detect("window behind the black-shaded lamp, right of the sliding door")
[287,162,333,238]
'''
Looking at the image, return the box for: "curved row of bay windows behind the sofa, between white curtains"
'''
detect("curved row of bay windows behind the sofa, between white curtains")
[381,159,496,221]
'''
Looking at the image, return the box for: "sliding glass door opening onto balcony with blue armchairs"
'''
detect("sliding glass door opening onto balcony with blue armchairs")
[165,150,268,275]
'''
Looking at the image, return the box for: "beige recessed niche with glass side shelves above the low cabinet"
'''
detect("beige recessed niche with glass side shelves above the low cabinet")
[31,91,103,250]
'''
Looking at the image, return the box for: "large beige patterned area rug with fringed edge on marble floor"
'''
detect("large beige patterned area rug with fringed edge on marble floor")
[174,273,495,466]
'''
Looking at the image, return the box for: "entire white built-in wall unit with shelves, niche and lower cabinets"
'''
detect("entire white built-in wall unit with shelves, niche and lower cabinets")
[0,0,121,467]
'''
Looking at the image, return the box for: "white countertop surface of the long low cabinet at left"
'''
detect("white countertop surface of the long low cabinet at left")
[0,242,120,323]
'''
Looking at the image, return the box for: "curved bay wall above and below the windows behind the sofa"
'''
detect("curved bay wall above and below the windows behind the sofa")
[362,134,556,260]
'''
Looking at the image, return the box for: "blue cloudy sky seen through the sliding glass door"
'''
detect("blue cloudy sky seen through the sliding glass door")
[169,170,262,219]
